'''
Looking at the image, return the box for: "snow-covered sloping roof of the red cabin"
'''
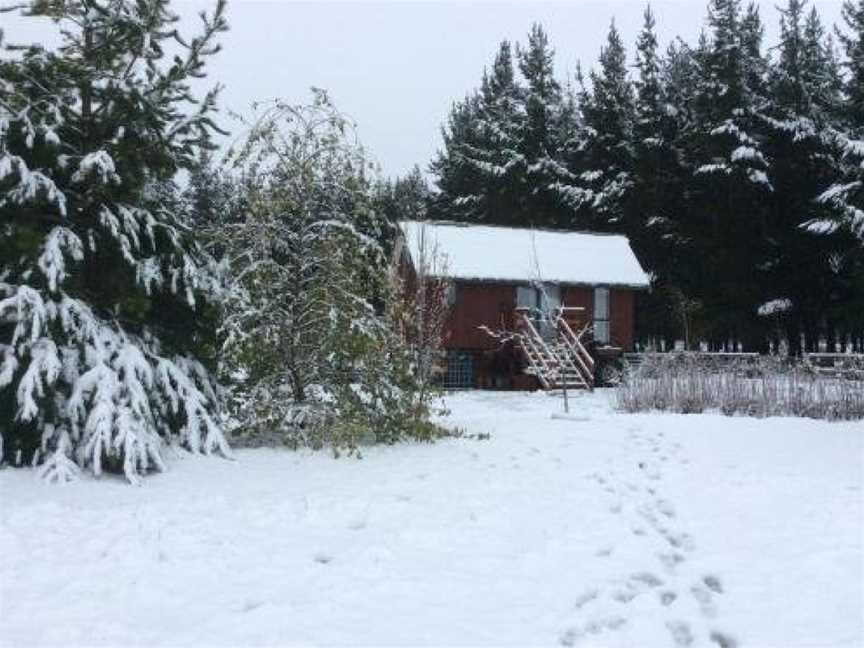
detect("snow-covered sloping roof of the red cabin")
[399,221,649,288]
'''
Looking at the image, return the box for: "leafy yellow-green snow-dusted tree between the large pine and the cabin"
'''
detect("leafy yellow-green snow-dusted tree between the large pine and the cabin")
[210,91,446,448]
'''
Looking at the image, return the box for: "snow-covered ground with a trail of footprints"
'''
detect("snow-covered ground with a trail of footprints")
[0,393,864,648]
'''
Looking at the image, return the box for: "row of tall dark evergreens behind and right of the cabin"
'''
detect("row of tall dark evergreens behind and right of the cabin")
[432,0,864,353]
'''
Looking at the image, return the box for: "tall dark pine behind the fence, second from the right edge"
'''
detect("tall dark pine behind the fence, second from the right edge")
[762,0,852,353]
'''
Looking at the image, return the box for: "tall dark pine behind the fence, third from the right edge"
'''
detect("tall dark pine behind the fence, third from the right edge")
[685,0,773,348]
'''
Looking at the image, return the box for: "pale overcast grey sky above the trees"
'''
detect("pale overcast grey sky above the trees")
[0,0,841,175]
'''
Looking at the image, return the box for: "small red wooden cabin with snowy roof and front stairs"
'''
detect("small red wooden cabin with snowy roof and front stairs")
[397,221,649,389]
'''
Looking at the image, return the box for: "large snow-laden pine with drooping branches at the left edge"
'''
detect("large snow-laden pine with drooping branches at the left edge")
[0,0,229,481]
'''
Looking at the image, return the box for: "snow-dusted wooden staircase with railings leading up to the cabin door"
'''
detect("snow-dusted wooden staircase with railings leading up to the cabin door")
[517,308,594,390]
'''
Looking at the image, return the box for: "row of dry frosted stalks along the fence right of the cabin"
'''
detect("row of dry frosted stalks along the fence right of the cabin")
[617,353,864,420]
